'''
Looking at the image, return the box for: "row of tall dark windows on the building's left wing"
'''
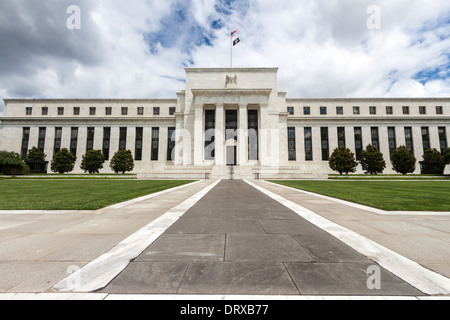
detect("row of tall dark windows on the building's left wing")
[21,127,175,161]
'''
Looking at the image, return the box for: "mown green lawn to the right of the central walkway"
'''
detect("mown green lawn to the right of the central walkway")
[273,181,450,212]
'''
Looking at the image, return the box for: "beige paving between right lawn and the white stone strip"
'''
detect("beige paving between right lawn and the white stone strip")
[255,181,450,277]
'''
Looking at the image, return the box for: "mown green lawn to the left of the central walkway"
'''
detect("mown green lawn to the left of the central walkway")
[0,179,192,210]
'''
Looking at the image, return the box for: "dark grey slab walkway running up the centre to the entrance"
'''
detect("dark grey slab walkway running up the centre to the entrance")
[101,181,423,296]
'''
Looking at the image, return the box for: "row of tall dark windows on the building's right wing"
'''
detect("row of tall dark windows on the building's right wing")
[288,127,448,161]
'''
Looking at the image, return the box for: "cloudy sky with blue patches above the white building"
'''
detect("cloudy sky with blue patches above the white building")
[0,0,450,112]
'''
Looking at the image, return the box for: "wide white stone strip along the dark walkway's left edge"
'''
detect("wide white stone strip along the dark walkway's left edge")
[53,180,220,292]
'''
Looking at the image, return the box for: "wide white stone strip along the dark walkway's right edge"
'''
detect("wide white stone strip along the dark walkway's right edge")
[244,180,450,295]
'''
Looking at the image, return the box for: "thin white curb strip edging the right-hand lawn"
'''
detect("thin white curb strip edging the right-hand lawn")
[264,180,450,216]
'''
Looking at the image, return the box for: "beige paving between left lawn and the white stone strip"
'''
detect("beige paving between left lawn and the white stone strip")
[0,181,211,293]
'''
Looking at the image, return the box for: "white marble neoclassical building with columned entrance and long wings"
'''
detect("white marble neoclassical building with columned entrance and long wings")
[0,68,450,179]
